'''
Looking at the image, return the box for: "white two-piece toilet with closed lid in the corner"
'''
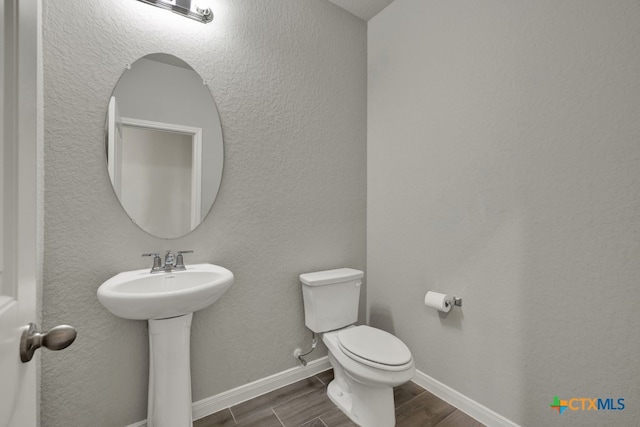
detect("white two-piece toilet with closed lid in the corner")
[300,268,415,427]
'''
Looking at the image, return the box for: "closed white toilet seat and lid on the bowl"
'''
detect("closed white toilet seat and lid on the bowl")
[337,325,413,371]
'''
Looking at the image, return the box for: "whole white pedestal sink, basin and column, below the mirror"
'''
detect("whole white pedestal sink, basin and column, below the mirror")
[98,264,233,427]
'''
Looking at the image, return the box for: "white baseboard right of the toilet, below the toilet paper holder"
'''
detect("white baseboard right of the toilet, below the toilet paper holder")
[413,370,520,427]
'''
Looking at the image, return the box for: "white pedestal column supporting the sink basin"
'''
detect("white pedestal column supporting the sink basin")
[147,313,193,427]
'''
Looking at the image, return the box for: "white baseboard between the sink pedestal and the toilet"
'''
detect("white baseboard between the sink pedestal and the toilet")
[127,356,331,427]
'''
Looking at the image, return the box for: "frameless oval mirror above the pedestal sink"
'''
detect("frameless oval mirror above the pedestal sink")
[105,53,224,239]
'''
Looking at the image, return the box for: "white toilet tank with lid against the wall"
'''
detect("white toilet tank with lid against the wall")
[300,268,364,333]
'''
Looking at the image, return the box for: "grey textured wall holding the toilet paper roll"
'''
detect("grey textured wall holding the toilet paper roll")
[367,0,640,426]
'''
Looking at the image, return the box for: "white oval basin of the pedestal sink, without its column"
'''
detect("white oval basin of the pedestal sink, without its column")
[98,264,233,320]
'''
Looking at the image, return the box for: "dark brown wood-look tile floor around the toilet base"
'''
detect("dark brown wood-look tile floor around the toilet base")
[193,370,484,427]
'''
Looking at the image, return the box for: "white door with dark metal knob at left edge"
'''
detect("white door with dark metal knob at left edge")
[0,0,39,427]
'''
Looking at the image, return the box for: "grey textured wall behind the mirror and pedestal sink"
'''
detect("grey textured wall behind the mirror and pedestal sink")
[42,0,366,427]
